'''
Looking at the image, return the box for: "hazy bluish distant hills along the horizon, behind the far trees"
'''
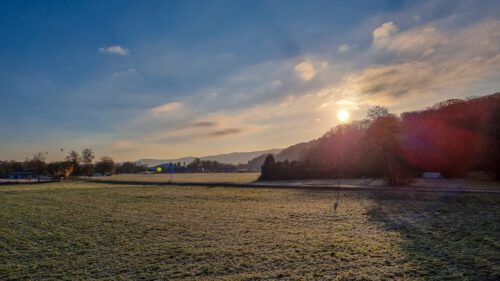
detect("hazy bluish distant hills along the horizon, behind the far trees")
[136,149,282,167]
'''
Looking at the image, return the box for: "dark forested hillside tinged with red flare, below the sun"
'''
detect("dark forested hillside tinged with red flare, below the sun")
[260,93,500,178]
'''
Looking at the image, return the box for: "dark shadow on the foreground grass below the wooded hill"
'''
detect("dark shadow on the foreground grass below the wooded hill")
[368,189,500,280]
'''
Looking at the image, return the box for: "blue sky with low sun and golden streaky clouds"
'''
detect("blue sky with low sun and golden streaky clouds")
[0,0,500,161]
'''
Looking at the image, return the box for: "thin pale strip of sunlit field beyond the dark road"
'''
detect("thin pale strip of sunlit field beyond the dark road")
[94,173,260,183]
